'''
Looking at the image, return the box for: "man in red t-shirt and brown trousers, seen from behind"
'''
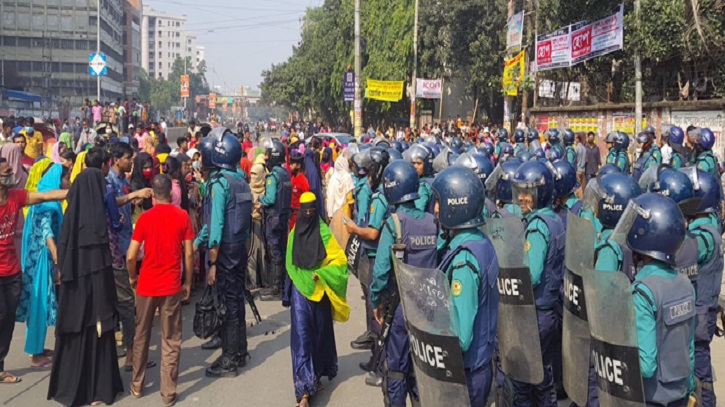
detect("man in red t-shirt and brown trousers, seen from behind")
[126,174,194,405]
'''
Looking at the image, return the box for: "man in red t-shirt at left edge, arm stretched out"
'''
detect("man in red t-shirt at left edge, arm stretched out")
[0,157,68,384]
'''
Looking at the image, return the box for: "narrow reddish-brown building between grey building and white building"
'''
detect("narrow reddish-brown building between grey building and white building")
[123,0,143,97]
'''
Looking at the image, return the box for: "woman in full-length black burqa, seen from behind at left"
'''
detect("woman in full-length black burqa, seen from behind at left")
[48,168,123,406]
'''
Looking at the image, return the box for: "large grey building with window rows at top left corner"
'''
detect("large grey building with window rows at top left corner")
[0,0,124,109]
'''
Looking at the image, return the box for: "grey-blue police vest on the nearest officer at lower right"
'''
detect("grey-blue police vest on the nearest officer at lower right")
[634,274,695,405]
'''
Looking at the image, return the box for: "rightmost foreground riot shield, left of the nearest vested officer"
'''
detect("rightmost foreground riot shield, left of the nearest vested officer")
[584,269,644,407]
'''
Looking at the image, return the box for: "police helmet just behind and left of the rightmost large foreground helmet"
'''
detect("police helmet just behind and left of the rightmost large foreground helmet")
[584,172,642,229]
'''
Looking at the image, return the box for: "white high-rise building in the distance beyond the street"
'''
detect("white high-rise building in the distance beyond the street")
[141,6,204,79]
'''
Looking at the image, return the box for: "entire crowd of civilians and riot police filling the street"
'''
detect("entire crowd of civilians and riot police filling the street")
[0,114,723,407]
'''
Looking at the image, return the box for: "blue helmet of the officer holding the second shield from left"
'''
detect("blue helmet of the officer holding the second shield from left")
[511,160,554,210]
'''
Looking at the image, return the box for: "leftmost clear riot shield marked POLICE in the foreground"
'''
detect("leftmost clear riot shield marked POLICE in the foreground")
[393,257,471,407]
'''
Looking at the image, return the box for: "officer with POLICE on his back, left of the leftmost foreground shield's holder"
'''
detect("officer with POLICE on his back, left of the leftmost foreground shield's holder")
[370,161,438,407]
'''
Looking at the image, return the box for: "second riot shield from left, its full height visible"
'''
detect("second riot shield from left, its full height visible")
[483,218,544,384]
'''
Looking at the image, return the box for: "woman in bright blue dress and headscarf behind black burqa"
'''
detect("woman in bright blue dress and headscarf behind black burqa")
[16,164,70,369]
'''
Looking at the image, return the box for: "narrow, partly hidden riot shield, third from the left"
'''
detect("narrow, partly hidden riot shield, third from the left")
[561,212,594,406]
